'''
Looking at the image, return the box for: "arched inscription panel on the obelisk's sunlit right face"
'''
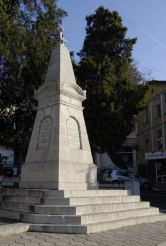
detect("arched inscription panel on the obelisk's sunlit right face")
[67,117,81,149]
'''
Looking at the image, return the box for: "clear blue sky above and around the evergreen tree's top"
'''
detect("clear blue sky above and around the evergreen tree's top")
[58,0,166,80]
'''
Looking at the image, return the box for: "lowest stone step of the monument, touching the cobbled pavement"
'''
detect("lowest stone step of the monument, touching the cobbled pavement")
[29,214,166,234]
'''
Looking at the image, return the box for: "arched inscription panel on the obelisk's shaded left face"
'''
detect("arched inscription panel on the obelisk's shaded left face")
[38,117,52,148]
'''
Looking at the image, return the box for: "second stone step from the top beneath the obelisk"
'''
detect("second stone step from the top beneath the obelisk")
[42,196,140,206]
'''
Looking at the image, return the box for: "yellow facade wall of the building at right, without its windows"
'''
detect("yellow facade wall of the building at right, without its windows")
[137,81,166,179]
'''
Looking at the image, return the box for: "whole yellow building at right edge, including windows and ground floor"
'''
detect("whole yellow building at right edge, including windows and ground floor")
[137,80,166,183]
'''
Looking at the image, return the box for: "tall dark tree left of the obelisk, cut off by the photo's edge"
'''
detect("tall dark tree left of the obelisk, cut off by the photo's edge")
[0,0,66,161]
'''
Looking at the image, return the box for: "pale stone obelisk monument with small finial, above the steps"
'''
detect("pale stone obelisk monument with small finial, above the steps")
[20,31,97,190]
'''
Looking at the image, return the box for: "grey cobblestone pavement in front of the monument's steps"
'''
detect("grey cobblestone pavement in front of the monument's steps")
[0,222,166,246]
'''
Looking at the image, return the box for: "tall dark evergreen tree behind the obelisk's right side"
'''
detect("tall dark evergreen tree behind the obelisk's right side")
[74,7,146,165]
